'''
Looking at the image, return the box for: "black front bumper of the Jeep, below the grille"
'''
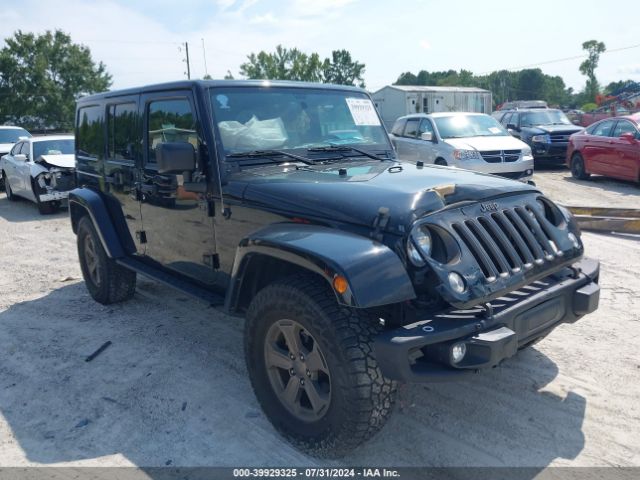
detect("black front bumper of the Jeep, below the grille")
[374,259,600,382]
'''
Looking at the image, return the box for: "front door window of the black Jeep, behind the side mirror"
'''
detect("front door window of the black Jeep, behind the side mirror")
[147,98,198,163]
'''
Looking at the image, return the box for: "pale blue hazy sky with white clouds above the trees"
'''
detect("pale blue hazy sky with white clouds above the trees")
[0,0,640,91]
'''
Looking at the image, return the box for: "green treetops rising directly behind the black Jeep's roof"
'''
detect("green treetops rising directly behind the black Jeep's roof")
[240,45,365,86]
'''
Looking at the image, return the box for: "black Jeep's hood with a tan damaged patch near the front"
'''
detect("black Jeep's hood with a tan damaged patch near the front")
[238,161,537,234]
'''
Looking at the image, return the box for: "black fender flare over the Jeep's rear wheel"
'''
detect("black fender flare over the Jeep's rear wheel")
[69,188,135,258]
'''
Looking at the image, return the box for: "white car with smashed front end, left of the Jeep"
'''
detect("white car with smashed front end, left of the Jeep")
[0,135,76,214]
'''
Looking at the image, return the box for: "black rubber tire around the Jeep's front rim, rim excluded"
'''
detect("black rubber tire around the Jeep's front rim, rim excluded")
[244,275,396,458]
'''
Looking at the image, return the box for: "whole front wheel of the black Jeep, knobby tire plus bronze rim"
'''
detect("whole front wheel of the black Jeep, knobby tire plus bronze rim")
[245,275,396,458]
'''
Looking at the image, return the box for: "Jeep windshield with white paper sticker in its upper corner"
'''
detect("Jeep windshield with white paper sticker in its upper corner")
[210,86,391,158]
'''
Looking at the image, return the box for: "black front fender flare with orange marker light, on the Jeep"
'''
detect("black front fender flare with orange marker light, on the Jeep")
[225,223,416,312]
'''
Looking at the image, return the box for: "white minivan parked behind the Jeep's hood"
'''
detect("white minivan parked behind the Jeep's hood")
[389,112,533,182]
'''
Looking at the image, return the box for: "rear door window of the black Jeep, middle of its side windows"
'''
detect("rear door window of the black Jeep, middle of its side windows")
[107,102,138,160]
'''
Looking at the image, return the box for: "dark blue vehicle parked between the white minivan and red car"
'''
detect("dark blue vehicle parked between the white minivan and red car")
[496,108,582,164]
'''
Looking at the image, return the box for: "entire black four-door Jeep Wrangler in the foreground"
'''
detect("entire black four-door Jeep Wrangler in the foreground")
[69,81,599,456]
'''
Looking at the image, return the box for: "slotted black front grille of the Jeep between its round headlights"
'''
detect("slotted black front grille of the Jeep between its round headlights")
[452,205,562,282]
